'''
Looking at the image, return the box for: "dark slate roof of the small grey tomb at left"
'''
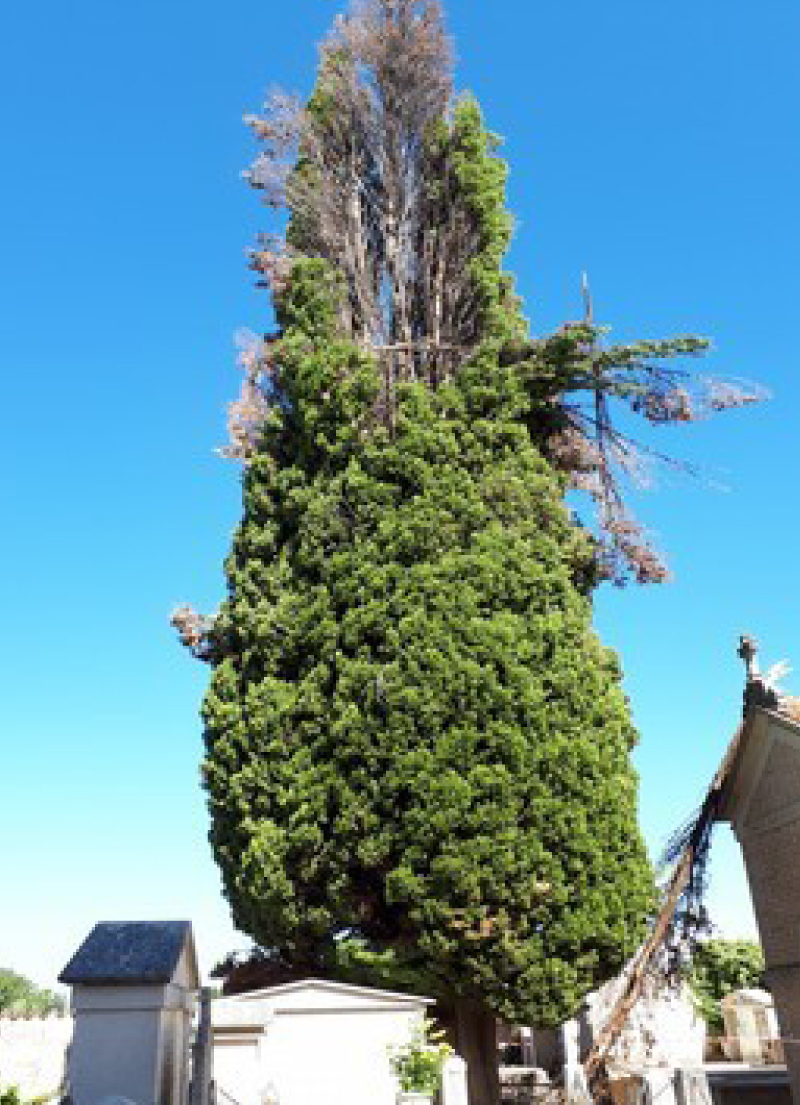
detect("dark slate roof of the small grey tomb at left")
[59,920,191,986]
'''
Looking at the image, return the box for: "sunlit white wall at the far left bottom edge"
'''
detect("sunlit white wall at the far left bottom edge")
[0,1017,73,1098]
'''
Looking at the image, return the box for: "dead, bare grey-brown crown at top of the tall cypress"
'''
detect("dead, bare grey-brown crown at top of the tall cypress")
[248,0,476,362]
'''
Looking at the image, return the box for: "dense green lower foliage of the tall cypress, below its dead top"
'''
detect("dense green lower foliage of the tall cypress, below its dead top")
[203,262,651,1023]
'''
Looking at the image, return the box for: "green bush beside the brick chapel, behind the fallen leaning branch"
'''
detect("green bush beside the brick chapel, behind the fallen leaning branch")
[688,939,764,1035]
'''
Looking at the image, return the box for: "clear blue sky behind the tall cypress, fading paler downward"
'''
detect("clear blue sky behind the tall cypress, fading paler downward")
[0,0,800,982]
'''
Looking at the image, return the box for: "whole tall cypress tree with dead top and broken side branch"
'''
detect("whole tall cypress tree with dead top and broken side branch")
[175,0,764,1105]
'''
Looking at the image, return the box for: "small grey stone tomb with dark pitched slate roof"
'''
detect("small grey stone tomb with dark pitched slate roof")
[60,922,198,1105]
